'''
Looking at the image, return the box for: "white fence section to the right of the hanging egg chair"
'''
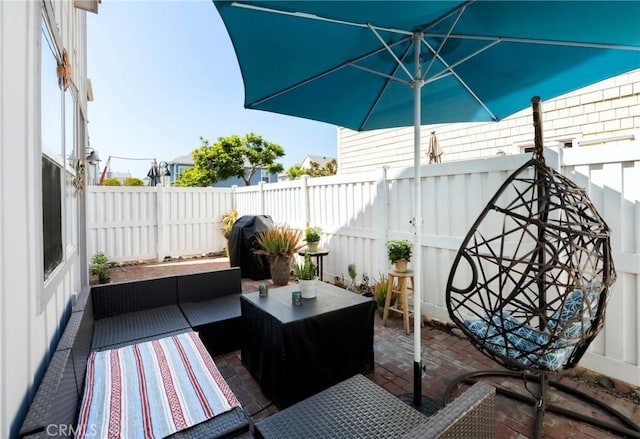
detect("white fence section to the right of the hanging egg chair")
[562,143,640,385]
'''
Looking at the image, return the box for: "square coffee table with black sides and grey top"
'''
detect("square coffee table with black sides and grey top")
[240,281,376,408]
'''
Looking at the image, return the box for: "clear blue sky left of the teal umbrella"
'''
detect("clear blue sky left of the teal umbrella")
[87,0,337,178]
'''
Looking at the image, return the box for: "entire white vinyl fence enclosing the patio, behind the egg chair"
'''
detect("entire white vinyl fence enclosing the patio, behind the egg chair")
[87,143,640,385]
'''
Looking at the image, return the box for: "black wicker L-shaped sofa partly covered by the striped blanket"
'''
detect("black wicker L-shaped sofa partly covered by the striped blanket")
[19,268,249,438]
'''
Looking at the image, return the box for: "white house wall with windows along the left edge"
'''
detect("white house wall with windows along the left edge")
[0,0,86,437]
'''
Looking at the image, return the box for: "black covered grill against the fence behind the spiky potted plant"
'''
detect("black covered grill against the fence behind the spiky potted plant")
[228,215,274,280]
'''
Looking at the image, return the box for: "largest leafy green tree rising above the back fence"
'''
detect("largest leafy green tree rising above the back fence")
[175,133,284,186]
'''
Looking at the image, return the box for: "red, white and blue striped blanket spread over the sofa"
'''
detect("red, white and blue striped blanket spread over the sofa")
[76,332,239,438]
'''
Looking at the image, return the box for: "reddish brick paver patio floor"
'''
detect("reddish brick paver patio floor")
[107,258,640,439]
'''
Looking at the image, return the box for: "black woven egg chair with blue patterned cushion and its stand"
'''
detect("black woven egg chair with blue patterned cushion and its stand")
[445,97,640,438]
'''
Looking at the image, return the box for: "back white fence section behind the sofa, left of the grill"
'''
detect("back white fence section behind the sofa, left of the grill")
[87,186,233,261]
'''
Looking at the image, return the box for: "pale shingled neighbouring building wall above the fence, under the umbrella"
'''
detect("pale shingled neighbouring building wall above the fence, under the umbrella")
[338,70,640,173]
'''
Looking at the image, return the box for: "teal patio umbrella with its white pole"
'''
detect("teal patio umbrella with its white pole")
[214,0,640,407]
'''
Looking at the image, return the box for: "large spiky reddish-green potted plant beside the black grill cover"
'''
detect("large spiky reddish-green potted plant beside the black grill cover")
[255,224,304,286]
